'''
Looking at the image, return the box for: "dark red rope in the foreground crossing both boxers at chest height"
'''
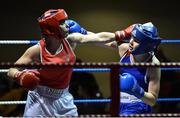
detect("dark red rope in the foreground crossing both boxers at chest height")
[0,62,180,70]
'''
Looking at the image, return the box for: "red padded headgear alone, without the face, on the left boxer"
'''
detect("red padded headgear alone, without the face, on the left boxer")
[38,9,68,37]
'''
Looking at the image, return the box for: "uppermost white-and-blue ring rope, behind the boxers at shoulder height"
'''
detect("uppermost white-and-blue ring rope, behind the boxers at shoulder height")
[0,39,180,45]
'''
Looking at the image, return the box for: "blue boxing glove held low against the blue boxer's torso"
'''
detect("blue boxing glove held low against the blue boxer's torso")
[120,73,145,98]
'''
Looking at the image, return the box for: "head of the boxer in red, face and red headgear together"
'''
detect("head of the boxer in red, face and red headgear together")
[38,9,68,40]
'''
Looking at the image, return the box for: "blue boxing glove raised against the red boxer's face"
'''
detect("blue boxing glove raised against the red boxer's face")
[65,20,87,34]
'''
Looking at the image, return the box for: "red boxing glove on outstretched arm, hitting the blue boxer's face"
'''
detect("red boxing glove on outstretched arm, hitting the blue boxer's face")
[115,24,136,43]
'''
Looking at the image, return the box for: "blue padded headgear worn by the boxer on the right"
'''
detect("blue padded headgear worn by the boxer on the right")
[132,22,161,55]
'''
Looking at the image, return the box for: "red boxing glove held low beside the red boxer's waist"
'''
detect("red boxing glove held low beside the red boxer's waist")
[15,70,40,90]
